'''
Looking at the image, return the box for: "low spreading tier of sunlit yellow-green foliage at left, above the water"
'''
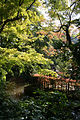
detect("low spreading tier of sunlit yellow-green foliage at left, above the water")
[0,48,52,80]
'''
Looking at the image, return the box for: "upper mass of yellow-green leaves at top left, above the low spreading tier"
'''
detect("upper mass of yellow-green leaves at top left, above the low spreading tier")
[0,0,45,48]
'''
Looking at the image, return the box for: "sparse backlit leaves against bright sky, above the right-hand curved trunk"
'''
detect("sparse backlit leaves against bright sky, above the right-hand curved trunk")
[47,0,80,25]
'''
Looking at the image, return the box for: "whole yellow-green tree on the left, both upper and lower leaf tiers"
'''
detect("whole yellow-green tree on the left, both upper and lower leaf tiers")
[0,0,57,81]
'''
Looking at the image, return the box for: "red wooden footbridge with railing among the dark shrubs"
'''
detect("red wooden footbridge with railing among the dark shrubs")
[33,74,80,92]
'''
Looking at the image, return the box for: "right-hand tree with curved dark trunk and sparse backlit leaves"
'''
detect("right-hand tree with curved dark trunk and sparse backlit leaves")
[47,0,80,45]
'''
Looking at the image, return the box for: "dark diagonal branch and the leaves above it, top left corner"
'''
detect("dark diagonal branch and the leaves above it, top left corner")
[0,0,37,33]
